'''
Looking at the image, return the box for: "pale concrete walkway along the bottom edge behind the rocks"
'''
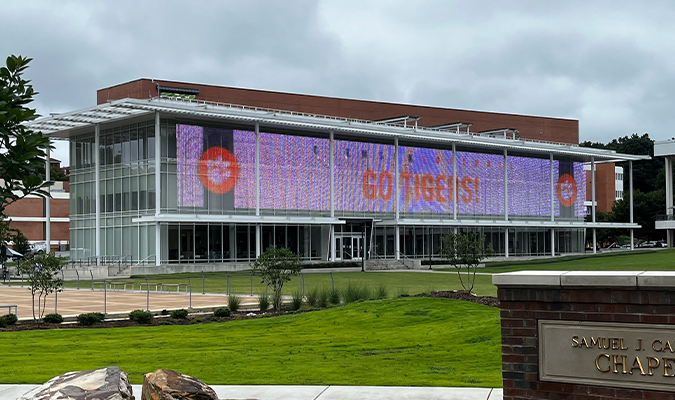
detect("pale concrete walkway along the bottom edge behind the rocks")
[0,385,503,400]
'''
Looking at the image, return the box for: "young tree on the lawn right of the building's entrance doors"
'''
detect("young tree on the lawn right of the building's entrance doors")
[441,232,492,293]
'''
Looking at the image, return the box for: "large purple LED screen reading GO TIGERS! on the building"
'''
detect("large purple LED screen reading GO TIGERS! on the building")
[176,125,586,218]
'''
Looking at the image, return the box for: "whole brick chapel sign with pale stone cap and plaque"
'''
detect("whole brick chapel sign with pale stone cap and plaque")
[493,271,675,400]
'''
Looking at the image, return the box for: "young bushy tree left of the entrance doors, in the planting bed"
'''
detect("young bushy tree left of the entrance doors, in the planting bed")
[253,248,302,311]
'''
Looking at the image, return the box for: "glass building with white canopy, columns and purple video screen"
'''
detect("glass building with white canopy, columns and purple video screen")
[30,98,644,265]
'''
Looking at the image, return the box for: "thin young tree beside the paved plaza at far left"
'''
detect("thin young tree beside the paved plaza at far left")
[20,253,66,320]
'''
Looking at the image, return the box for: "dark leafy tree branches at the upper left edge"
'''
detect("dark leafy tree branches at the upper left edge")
[0,55,51,215]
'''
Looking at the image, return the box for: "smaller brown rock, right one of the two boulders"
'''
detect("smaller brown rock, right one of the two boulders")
[141,369,218,400]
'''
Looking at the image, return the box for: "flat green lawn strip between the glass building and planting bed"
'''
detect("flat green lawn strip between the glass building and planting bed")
[66,272,497,297]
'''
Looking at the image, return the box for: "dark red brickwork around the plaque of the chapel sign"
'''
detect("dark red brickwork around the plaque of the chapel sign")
[498,288,675,400]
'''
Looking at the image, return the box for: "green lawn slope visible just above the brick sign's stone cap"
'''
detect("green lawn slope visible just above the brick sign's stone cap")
[479,249,675,273]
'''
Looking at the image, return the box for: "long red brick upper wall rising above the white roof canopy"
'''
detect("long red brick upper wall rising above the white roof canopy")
[96,79,579,144]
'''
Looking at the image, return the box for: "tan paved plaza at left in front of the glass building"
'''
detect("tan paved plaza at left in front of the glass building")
[0,285,258,319]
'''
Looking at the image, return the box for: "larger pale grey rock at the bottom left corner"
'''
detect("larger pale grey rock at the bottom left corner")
[18,367,134,400]
